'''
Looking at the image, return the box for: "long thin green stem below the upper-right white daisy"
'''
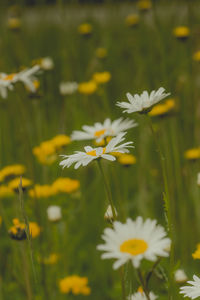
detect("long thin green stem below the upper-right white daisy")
[147,115,174,299]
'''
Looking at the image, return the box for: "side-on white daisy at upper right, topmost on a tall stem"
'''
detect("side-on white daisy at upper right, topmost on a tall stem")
[117,87,170,114]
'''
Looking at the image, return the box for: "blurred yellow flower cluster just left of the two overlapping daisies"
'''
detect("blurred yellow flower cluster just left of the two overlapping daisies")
[33,134,71,165]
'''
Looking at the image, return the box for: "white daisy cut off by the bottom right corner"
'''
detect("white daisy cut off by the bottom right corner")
[180,275,200,299]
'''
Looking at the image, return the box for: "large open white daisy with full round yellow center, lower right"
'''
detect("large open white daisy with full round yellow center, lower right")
[97,217,170,269]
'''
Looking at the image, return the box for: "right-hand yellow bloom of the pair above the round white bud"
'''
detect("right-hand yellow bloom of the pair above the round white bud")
[52,177,80,194]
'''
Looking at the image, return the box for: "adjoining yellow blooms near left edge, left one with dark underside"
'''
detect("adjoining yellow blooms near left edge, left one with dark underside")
[9,218,41,240]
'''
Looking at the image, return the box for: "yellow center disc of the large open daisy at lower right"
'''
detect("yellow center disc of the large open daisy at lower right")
[120,239,148,255]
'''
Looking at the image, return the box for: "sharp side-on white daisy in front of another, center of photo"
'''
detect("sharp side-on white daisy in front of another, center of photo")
[60,132,133,169]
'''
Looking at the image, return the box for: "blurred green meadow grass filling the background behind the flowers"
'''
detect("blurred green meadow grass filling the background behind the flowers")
[0,0,200,300]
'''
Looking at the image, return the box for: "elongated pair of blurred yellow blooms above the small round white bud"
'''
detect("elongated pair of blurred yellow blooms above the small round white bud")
[29,177,80,198]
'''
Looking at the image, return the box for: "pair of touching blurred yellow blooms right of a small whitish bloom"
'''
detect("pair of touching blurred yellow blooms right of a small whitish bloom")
[78,71,111,95]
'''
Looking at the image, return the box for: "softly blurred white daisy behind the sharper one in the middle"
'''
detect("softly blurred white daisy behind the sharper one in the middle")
[71,118,138,143]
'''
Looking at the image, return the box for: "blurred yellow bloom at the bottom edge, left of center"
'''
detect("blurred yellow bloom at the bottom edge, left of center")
[59,275,91,295]
